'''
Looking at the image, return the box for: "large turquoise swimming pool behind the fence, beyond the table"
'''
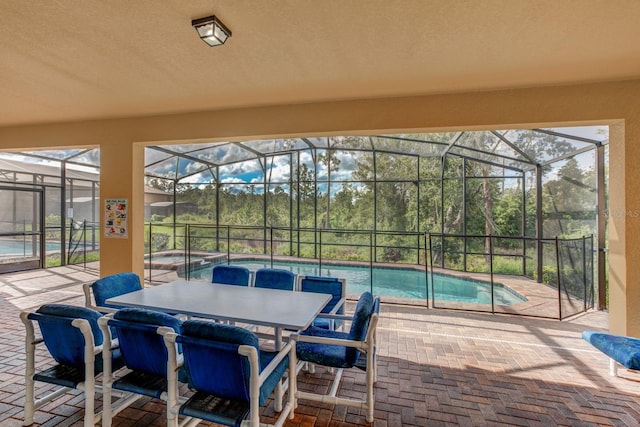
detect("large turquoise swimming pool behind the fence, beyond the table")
[184,260,527,305]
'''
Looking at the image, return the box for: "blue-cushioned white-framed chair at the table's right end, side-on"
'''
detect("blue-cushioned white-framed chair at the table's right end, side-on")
[290,292,379,422]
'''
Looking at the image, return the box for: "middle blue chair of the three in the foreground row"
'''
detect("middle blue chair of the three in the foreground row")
[98,308,182,427]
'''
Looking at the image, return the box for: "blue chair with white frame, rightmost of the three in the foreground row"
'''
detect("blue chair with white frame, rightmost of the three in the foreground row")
[164,320,296,427]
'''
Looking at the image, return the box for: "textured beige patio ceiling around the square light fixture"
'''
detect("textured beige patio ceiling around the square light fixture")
[0,0,640,126]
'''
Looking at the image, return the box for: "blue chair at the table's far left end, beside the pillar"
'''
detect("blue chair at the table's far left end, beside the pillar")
[82,273,142,313]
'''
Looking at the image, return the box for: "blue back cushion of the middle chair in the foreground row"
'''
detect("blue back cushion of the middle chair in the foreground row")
[109,308,182,377]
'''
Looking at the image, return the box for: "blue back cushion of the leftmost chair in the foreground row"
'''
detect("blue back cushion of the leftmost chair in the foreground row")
[29,304,103,368]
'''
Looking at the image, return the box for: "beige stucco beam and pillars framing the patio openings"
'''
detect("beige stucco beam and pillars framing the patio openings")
[0,80,640,336]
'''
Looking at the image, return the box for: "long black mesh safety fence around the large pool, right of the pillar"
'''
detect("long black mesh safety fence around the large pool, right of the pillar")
[145,223,594,319]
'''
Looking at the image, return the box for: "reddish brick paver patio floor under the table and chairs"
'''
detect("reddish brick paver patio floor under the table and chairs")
[0,267,640,427]
